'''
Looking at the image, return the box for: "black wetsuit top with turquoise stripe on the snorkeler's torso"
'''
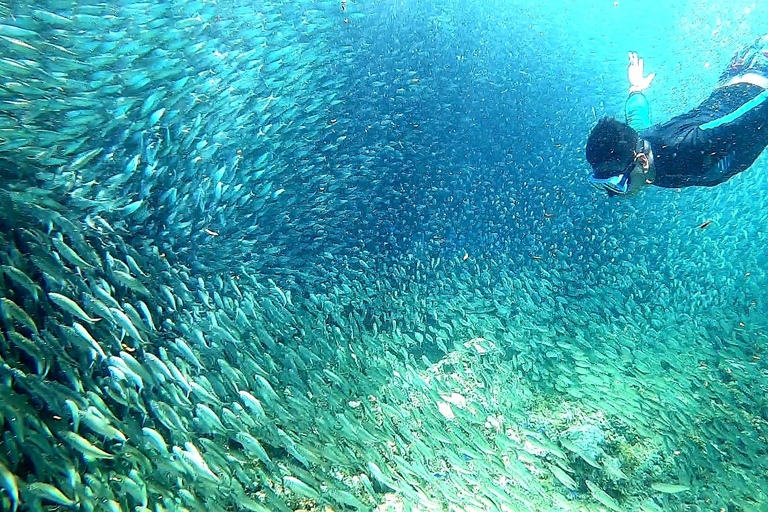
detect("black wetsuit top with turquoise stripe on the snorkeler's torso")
[640,83,768,188]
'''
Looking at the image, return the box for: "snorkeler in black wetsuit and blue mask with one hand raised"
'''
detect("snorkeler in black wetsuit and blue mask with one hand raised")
[586,35,768,196]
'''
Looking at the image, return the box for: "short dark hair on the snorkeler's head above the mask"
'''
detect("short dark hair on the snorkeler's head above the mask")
[587,117,640,177]
